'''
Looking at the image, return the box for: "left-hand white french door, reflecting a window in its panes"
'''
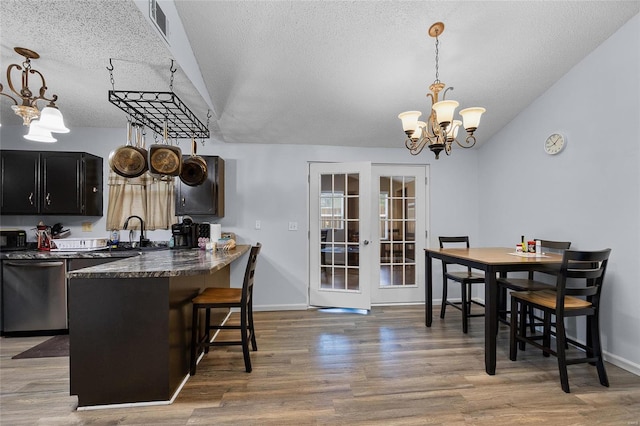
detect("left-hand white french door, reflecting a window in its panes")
[309,163,373,309]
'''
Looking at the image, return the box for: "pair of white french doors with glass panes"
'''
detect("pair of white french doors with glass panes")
[309,163,427,309]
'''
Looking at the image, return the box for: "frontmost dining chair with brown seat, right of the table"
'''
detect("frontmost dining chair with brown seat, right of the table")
[509,249,611,393]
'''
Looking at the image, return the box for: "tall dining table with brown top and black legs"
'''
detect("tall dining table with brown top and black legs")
[425,247,562,375]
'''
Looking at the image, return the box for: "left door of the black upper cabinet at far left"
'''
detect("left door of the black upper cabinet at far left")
[0,151,40,214]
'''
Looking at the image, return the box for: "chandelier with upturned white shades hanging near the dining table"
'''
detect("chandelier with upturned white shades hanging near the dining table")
[398,22,486,160]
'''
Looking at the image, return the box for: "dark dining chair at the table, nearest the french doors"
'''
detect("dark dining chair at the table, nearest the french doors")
[438,236,484,333]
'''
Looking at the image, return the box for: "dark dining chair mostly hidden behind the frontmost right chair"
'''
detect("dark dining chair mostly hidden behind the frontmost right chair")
[496,240,571,332]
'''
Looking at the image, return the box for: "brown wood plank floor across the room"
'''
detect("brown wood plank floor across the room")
[0,306,640,426]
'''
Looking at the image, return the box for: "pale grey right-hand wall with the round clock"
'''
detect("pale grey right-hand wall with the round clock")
[479,16,640,374]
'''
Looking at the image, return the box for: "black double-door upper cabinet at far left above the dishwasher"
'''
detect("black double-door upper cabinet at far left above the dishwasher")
[0,150,102,216]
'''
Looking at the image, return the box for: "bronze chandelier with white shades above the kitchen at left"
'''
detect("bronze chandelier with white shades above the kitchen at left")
[0,47,69,142]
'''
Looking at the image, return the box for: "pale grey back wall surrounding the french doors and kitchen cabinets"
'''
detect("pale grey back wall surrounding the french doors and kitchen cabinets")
[0,123,479,309]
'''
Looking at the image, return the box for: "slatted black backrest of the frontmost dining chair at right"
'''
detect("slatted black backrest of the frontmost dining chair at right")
[556,249,611,309]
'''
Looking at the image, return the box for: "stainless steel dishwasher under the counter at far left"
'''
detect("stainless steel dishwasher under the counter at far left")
[2,259,68,335]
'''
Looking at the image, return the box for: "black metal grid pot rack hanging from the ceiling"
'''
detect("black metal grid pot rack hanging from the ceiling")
[109,90,209,139]
